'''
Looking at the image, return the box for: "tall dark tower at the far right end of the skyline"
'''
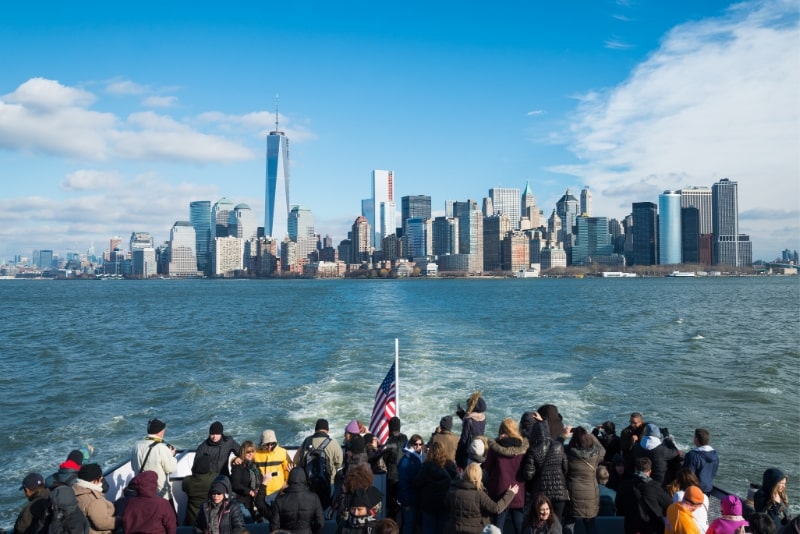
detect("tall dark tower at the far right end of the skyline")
[711,178,753,267]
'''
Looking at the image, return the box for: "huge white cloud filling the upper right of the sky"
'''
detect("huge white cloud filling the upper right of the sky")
[554,1,800,257]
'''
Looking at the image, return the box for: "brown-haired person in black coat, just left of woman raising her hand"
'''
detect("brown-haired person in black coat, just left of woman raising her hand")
[414,440,458,534]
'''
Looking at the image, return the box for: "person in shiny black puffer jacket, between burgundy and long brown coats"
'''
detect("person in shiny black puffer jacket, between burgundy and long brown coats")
[521,412,569,518]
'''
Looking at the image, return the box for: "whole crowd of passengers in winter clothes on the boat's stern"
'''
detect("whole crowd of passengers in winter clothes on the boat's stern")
[9,392,800,534]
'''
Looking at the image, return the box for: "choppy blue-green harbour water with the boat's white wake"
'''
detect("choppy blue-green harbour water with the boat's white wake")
[0,277,800,526]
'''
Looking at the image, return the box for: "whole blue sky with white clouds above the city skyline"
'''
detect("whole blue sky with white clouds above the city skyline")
[0,0,800,260]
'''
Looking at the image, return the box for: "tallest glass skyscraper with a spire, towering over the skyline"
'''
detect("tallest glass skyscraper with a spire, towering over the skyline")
[264,105,289,241]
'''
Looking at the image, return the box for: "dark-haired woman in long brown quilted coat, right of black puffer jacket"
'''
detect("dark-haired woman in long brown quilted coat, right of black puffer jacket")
[564,426,606,534]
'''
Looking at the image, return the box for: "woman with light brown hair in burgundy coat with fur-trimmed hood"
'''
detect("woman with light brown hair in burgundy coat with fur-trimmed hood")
[483,417,528,534]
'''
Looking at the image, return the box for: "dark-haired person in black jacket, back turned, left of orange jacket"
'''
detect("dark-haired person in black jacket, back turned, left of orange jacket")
[614,457,672,534]
